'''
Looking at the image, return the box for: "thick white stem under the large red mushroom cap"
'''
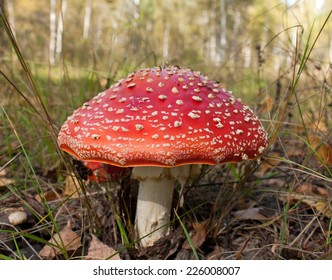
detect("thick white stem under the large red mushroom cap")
[132,165,197,247]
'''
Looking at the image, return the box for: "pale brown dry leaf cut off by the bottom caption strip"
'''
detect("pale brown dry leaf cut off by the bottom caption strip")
[85,235,120,260]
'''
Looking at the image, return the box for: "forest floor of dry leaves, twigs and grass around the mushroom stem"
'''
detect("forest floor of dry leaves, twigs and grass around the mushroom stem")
[0,128,332,260]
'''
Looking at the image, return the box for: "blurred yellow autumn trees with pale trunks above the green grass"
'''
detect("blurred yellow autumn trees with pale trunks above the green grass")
[1,0,332,82]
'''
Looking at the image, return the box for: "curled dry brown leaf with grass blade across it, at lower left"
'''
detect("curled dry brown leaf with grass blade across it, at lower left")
[39,220,81,258]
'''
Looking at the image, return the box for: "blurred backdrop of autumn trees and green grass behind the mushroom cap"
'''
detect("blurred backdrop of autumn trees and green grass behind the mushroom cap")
[0,0,332,148]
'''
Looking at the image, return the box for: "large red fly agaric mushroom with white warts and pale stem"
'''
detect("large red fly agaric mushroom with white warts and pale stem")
[58,66,267,247]
